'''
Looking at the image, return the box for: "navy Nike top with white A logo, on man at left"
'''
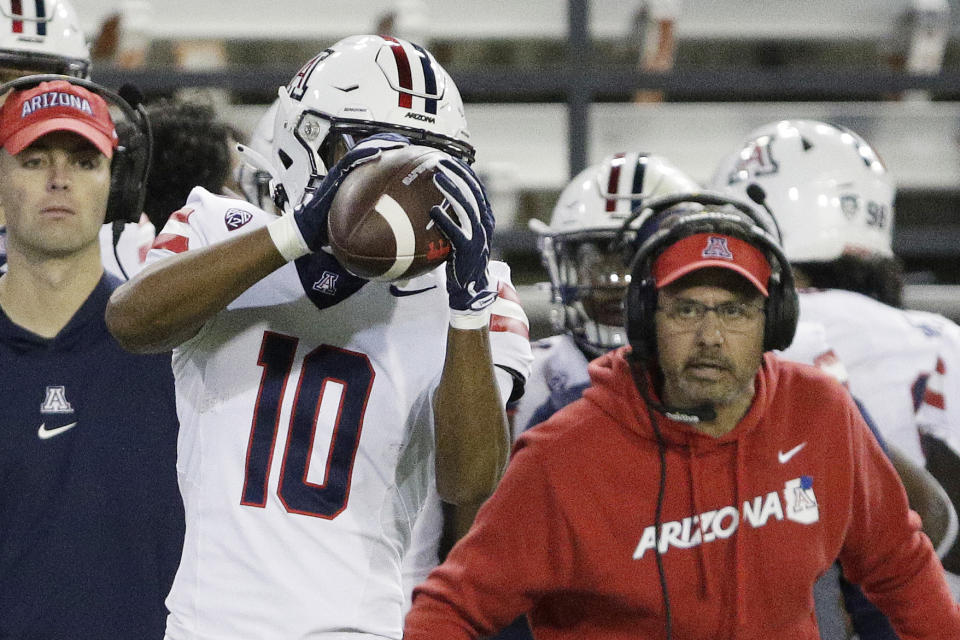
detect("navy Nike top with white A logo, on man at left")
[0,275,184,640]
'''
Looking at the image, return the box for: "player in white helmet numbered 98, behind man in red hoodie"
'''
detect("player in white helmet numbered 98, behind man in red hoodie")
[712,120,960,632]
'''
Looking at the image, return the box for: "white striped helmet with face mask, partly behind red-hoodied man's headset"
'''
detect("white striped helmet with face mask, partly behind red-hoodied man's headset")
[530,152,700,355]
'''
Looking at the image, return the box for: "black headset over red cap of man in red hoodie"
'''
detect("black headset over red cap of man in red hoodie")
[623,192,800,362]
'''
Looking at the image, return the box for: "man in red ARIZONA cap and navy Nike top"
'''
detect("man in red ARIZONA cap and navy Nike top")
[0,80,183,640]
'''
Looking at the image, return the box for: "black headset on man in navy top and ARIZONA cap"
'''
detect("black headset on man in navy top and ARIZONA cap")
[0,74,153,225]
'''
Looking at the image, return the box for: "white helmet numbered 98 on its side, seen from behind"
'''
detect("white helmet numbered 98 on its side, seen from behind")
[713,120,895,263]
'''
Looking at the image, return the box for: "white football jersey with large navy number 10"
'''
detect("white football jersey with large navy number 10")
[147,188,530,640]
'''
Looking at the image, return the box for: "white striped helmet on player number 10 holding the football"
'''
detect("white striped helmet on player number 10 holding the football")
[269,35,474,211]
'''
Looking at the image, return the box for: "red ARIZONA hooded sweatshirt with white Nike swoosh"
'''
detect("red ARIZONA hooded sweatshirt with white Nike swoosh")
[404,348,960,640]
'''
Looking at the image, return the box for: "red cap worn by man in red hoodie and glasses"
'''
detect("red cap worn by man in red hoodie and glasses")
[653,233,771,296]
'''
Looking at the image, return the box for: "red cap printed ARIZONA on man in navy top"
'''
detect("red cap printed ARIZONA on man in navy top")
[0,80,118,158]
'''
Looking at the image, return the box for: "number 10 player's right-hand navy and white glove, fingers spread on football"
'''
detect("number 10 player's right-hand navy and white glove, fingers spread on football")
[430,158,497,329]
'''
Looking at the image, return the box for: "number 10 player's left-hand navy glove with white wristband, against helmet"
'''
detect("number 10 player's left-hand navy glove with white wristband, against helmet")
[267,133,410,261]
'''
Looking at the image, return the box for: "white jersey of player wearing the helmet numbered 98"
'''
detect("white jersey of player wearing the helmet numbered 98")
[800,289,957,466]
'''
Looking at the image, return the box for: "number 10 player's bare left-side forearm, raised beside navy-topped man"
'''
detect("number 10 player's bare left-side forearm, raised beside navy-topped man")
[106,228,286,353]
